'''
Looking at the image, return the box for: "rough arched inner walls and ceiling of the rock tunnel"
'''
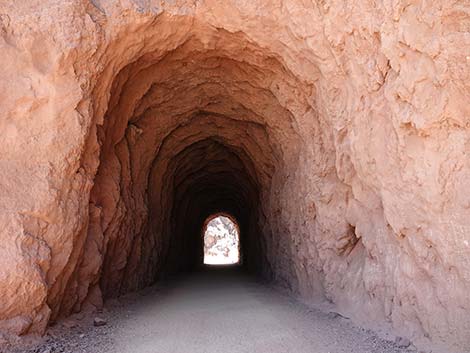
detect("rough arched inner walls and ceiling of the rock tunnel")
[44,15,344,332]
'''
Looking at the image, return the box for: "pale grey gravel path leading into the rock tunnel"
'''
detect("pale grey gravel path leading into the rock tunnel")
[5,269,416,353]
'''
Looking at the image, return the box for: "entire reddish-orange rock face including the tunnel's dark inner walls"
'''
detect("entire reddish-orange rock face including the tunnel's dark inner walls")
[0,0,470,352]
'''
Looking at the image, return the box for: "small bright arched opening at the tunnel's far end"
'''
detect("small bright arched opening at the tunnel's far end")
[203,214,240,265]
